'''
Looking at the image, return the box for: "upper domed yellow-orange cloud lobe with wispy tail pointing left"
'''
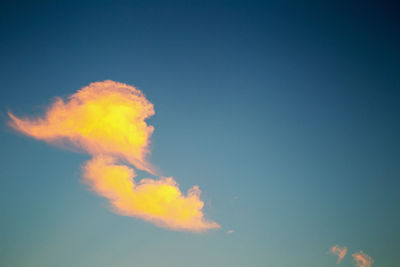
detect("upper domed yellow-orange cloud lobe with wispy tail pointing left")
[8,81,154,173]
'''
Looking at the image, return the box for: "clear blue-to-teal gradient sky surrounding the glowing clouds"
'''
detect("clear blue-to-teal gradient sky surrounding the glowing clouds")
[0,0,400,267]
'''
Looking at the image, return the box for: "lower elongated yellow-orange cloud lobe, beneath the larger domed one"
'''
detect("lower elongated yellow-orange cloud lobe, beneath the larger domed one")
[84,156,218,231]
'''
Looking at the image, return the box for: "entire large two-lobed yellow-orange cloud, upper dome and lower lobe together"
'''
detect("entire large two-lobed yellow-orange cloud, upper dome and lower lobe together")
[9,81,220,232]
